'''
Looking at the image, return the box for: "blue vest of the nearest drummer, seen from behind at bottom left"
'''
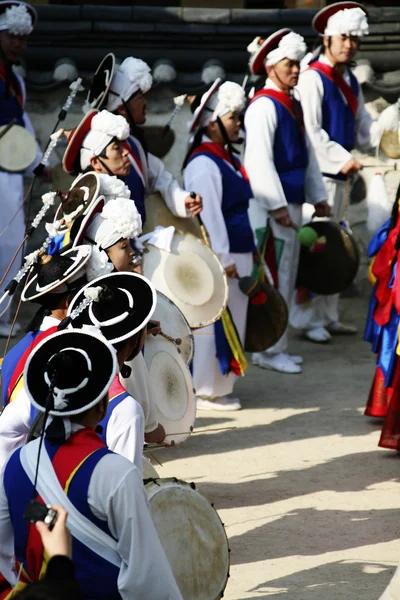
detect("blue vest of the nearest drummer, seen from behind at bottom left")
[4,440,120,600]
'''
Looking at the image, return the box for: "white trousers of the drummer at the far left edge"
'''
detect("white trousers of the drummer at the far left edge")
[0,171,25,325]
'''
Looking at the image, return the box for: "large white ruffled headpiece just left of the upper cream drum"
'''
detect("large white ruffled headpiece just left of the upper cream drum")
[86,198,142,250]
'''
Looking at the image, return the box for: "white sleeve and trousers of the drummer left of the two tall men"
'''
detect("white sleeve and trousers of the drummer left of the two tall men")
[185,144,253,398]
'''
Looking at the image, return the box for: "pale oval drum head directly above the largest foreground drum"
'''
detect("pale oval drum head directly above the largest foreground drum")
[144,335,196,444]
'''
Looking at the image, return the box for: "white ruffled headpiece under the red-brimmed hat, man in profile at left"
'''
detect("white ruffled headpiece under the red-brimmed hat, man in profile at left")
[80,110,129,171]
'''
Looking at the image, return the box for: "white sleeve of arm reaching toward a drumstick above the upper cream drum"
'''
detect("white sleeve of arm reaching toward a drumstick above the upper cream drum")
[147,153,189,217]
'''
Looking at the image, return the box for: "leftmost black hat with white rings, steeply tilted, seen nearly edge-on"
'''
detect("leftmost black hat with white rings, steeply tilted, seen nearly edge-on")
[21,245,91,302]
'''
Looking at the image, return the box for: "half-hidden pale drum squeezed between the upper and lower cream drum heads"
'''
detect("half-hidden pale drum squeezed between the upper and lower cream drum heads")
[152,292,194,365]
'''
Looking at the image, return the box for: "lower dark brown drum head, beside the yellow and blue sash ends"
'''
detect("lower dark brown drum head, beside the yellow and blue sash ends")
[245,281,289,352]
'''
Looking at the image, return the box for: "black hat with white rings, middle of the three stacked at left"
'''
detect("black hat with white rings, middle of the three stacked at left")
[68,272,157,344]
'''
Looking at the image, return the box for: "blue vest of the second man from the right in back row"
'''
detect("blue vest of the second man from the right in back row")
[254,96,308,204]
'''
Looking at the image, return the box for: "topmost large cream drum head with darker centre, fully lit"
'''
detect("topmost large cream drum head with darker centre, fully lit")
[142,233,229,329]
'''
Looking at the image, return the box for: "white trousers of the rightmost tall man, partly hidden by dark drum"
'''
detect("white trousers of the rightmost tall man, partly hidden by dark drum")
[290,177,346,329]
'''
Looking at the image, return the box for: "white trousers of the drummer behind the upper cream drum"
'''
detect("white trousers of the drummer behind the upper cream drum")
[193,252,253,399]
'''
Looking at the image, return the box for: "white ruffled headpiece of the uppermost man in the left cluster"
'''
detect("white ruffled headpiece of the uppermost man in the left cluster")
[107,56,153,112]
